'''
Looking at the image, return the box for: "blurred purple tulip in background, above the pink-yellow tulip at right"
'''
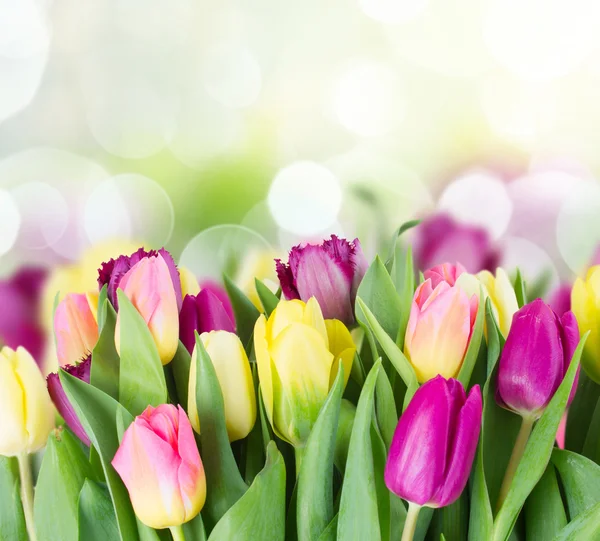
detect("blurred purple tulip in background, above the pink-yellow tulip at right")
[413,214,500,274]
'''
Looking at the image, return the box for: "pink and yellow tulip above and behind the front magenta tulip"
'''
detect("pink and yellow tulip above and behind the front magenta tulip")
[404,278,479,382]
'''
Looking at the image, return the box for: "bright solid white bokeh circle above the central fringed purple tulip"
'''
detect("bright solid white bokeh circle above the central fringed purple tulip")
[268,161,342,236]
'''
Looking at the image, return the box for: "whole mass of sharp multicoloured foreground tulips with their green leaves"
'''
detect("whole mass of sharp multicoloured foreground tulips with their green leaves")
[0,228,600,541]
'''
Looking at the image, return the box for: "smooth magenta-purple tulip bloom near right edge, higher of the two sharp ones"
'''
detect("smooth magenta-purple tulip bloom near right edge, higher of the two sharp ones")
[496,299,579,419]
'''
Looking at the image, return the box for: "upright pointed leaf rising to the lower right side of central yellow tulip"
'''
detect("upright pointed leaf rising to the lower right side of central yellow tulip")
[296,362,344,541]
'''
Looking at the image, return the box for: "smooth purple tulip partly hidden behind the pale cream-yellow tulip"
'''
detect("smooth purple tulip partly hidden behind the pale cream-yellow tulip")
[179,288,235,354]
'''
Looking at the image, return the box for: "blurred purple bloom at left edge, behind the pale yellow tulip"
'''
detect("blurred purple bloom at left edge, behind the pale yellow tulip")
[0,268,46,363]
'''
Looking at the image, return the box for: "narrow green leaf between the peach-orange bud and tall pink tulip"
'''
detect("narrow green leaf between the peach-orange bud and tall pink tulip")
[90,298,120,400]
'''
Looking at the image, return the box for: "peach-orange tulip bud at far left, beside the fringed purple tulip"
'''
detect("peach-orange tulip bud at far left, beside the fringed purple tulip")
[54,293,98,366]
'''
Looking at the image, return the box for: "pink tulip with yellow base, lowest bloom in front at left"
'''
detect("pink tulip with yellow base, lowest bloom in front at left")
[112,404,206,529]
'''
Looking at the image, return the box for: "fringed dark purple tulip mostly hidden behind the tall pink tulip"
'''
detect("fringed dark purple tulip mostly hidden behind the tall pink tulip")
[98,248,183,310]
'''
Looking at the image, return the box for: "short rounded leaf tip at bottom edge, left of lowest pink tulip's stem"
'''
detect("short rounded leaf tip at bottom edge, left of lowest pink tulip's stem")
[79,479,120,541]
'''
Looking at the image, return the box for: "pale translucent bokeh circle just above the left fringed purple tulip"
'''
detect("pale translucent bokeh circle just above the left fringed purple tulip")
[84,174,175,247]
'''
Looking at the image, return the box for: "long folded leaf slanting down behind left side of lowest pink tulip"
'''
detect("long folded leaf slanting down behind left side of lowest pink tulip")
[59,370,138,541]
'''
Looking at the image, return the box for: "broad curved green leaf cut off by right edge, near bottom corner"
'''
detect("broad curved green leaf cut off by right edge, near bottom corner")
[552,449,600,519]
